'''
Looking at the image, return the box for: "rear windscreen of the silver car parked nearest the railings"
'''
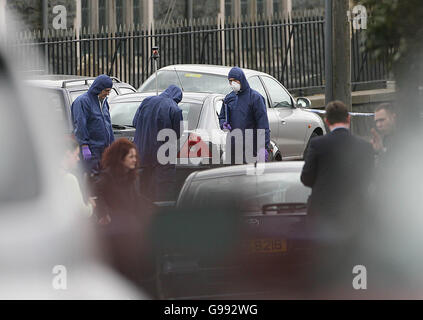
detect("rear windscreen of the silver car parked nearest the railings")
[138,70,231,95]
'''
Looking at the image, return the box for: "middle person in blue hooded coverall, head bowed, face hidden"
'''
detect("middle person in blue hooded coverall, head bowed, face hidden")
[133,85,183,201]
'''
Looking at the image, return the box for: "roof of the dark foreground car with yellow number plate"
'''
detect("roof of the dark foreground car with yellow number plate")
[192,161,304,181]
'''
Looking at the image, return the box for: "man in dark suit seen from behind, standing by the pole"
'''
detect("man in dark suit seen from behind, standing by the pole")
[301,101,374,298]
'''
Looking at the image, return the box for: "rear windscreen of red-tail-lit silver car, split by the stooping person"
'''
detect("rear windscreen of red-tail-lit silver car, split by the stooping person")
[110,102,202,130]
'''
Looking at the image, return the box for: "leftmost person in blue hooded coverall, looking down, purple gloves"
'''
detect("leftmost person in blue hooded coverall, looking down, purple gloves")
[71,75,114,173]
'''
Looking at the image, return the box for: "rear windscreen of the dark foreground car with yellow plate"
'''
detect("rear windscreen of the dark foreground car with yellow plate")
[178,172,310,212]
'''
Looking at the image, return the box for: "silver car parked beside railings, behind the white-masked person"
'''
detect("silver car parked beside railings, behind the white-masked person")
[138,65,326,161]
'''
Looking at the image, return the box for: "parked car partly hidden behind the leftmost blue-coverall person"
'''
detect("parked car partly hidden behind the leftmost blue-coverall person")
[26,75,136,132]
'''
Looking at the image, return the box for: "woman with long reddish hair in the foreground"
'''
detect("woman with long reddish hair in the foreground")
[96,138,152,283]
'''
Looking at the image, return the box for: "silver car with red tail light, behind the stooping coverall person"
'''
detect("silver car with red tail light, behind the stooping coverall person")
[109,92,230,195]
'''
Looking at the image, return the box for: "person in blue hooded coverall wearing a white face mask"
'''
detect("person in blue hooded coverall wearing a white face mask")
[219,67,270,164]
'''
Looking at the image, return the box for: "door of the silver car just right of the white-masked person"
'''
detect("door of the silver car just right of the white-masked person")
[261,76,307,159]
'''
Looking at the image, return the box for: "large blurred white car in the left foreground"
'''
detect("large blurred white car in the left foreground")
[0,38,144,300]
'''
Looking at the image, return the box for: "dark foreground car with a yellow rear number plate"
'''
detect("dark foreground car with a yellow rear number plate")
[153,162,311,298]
